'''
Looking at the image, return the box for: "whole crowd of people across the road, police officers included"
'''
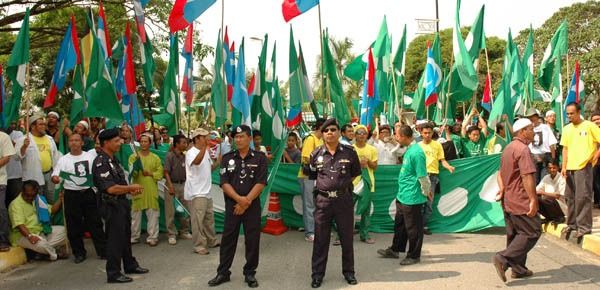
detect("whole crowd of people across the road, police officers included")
[0,103,600,288]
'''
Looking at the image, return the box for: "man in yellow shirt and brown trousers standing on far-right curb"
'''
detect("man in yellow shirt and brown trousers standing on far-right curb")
[560,102,600,239]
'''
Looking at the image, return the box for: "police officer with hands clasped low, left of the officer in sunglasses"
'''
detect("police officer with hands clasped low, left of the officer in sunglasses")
[208,125,268,288]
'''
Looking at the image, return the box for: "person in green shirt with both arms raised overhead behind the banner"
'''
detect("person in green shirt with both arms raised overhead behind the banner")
[461,109,488,158]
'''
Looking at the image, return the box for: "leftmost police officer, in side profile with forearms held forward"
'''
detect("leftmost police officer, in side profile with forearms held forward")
[92,129,149,283]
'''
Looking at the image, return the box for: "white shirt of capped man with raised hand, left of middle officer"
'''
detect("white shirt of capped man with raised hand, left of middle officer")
[183,147,212,200]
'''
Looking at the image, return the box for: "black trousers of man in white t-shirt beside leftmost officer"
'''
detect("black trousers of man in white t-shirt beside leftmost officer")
[64,188,106,257]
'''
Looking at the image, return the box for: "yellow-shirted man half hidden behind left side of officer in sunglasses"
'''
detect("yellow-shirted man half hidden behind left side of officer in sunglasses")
[298,118,325,242]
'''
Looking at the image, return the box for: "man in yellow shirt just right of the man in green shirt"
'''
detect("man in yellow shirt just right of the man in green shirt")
[419,123,454,235]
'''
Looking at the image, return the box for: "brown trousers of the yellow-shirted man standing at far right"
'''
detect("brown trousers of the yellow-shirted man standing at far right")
[565,163,593,234]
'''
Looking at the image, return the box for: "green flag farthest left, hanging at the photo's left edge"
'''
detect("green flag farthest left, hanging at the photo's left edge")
[2,8,29,129]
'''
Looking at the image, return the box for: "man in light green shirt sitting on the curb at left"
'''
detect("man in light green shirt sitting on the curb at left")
[8,180,68,261]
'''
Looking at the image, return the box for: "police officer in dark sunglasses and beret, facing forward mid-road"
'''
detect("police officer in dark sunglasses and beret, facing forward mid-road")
[304,119,361,288]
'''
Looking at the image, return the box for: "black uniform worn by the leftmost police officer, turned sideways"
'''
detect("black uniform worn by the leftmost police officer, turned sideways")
[92,150,139,280]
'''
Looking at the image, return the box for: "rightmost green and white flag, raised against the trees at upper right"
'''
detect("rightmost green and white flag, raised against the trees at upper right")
[538,19,569,90]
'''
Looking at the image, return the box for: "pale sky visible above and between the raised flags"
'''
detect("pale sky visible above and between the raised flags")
[194,0,584,81]
